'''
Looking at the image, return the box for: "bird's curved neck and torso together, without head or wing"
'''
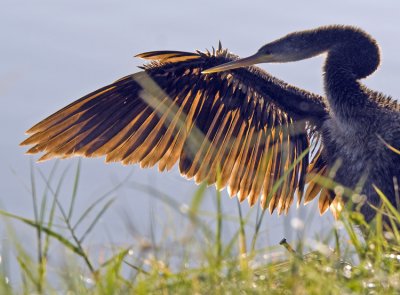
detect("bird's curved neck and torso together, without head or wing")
[319,27,400,221]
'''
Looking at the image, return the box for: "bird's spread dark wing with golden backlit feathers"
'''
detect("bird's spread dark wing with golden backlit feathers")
[21,44,328,213]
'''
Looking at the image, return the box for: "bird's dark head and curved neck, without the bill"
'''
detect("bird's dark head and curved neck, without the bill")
[258,26,380,121]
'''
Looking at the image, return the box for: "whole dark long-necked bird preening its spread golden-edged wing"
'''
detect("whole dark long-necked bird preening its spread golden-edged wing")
[21,26,400,224]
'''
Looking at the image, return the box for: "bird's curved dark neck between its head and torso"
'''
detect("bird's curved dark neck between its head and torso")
[317,28,379,120]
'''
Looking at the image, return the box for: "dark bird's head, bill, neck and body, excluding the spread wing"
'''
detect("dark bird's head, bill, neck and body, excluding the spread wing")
[204,26,400,221]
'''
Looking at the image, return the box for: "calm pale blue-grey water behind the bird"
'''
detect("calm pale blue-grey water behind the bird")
[0,0,400,272]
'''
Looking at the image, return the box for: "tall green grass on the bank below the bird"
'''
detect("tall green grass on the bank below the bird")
[0,163,400,294]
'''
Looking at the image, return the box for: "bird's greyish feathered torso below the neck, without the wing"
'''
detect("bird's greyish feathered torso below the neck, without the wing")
[321,92,400,220]
